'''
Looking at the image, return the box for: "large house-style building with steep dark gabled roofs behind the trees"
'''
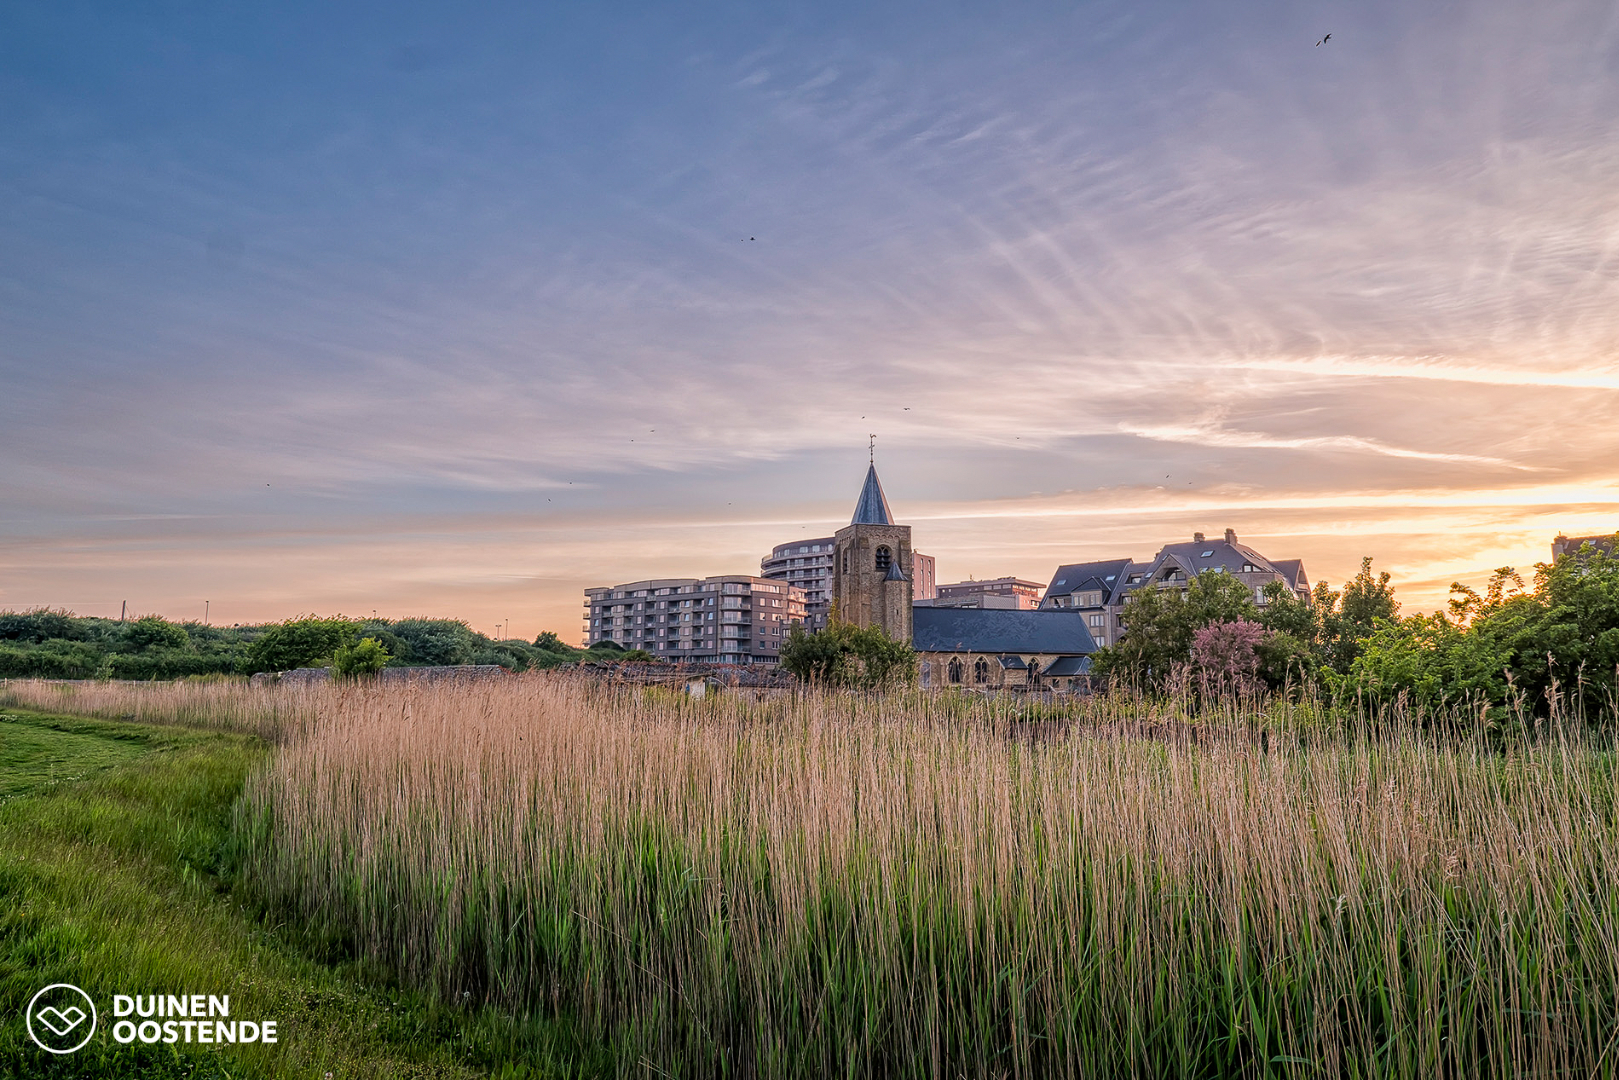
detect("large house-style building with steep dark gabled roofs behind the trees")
[1039,529,1310,646]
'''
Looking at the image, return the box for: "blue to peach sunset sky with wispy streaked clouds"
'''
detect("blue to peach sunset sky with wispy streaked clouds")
[0,0,1619,640]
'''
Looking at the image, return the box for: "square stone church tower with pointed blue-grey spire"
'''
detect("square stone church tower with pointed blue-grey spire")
[832,463,913,644]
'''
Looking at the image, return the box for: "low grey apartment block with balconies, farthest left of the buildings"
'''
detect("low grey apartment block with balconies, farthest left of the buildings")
[584,575,805,664]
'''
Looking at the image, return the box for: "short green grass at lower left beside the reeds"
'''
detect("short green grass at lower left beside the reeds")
[0,709,601,1080]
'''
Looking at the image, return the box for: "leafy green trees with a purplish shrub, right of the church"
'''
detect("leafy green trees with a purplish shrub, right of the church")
[1093,536,1619,716]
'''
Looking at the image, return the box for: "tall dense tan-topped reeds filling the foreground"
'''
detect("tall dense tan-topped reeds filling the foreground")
[215,677,1619,1077]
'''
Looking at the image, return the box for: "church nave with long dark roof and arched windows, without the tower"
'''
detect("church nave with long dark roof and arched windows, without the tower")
[911,607,1096,691]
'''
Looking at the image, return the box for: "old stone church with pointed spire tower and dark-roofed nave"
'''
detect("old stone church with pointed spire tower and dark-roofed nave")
[832,461,1096,690]
